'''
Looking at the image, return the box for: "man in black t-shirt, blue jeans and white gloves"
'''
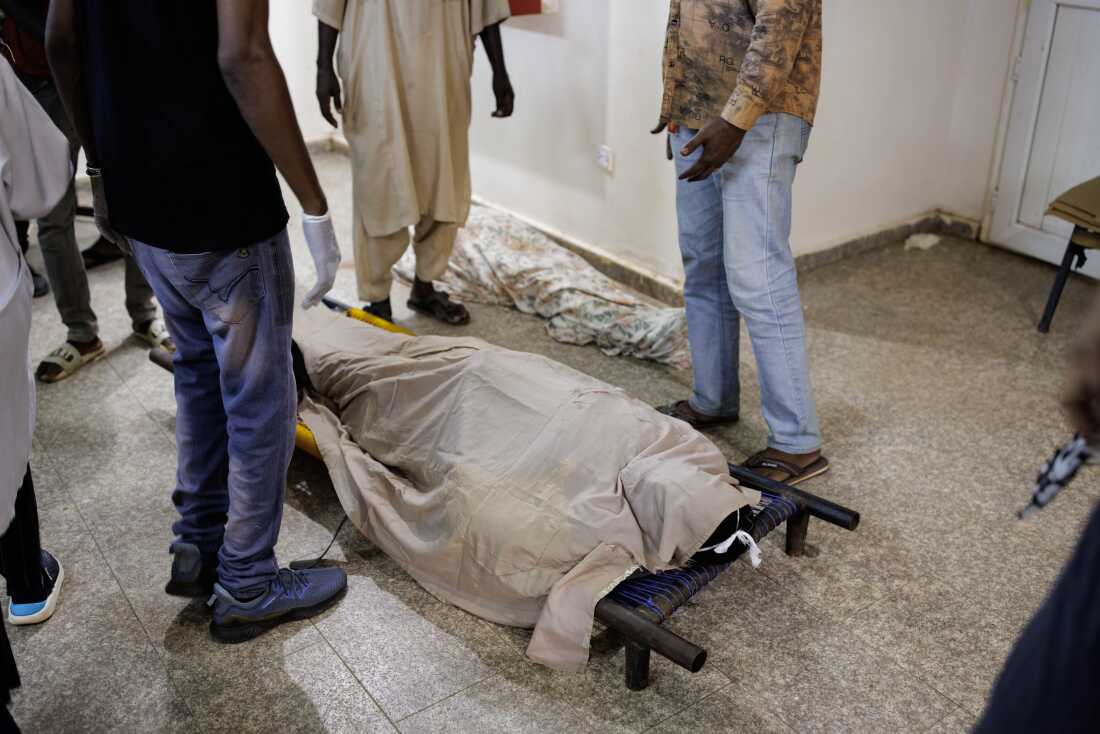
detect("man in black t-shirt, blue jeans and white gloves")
[46,0,347,642]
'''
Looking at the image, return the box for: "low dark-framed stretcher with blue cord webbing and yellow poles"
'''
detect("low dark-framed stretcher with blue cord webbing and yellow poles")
[150,298,859,691]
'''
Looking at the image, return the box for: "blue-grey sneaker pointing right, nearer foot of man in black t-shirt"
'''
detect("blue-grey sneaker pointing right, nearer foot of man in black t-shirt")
[207,568,348,643]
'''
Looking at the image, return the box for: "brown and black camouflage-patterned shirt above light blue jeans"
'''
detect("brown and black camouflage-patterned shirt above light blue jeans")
[661,0,822,130]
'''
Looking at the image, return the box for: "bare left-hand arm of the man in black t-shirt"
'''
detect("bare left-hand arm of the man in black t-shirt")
[46,0,99,168]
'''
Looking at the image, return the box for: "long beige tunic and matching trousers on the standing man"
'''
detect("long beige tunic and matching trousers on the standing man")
[314,0,509,300]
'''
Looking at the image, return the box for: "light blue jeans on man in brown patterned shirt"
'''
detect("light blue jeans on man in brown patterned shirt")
[672,113,821,453]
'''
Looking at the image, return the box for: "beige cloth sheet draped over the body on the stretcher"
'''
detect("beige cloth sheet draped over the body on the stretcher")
[295,309,759,670]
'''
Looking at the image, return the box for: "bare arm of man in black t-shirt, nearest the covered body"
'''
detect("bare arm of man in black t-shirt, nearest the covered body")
[218,0,329,216]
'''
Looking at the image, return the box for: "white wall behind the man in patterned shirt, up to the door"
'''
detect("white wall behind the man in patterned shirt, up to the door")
[471,0,1016,277]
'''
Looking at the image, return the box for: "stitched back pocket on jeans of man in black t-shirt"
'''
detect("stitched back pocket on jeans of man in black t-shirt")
[168,248,266,324]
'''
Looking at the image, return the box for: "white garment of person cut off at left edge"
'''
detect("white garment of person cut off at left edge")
[0,61,73,533]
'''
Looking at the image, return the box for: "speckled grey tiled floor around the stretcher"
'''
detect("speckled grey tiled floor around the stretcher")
[10,151,1100,734]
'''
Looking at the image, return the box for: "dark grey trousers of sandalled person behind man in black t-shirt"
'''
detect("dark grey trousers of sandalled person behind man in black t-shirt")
[23,78,156,341]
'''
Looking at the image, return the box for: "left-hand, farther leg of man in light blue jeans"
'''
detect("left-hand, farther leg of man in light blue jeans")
[672,128,740,418]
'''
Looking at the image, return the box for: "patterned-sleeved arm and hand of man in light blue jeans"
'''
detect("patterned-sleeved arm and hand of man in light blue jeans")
[680,0,814,180]
